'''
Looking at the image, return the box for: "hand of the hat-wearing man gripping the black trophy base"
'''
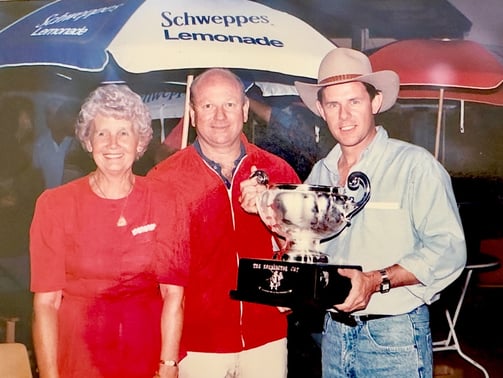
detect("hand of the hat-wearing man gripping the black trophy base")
[334,268,376,313]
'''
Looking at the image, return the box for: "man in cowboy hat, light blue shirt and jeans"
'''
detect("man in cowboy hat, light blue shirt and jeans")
[242,48,466,378]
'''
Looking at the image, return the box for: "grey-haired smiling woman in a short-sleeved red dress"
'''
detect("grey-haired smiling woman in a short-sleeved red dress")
[30,85,186,378]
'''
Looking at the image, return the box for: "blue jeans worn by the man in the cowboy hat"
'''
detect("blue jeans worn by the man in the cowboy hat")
[321,305,433,378]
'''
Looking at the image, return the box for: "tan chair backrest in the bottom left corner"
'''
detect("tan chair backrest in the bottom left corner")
[0,343,33,378]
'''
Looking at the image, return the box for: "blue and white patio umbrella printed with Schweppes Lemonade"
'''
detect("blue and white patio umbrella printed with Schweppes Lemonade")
[0,0,336,146]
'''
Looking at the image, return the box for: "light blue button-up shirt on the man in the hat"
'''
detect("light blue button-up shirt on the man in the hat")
[306,126,466,314]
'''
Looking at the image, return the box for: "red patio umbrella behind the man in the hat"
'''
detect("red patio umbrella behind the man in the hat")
[369,39,503,159]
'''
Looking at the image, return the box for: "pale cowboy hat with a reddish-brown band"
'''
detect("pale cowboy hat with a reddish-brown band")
[295,47,400,116]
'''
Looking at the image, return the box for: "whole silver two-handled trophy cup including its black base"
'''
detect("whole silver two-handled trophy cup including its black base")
[230,171,370,308]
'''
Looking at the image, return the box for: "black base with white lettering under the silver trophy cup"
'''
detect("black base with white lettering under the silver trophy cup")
[230,258,362,309]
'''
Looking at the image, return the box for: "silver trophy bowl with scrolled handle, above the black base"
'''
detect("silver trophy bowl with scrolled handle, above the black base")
[257,172,370,263]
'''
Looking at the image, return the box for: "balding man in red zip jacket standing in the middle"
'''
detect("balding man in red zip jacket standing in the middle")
[147,69,299,378]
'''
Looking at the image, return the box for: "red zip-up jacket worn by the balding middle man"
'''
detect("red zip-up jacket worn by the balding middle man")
[148,136,299,353]
